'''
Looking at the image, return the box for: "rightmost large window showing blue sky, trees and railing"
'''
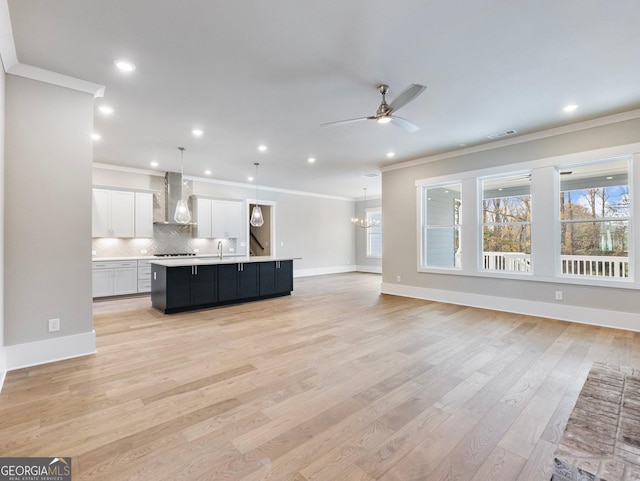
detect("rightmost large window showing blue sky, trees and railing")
[557,158,631,278]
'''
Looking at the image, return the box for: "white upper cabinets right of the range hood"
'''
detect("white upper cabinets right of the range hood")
[192,197,248,239]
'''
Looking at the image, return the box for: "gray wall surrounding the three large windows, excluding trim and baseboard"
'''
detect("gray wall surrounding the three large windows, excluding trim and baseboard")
[382,114,640,313]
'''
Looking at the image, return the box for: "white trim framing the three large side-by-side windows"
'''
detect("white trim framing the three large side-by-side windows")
[415,142,640,290]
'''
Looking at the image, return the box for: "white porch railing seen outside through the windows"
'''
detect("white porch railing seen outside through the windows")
[482,252,629,278]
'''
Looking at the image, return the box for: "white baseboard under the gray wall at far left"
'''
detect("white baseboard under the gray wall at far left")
[5,331,96,371]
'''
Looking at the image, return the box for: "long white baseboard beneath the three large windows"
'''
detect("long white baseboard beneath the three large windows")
[380,282,640,331]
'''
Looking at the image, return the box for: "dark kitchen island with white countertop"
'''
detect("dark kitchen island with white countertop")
[151,256,294,314]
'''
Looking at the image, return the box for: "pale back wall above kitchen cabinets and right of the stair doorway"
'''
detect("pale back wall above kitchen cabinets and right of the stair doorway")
[89,169,356,275]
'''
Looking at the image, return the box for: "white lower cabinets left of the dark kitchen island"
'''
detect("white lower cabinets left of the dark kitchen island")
[92,260,138,297]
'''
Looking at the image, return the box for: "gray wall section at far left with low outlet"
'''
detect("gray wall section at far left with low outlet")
[4,75,93,346]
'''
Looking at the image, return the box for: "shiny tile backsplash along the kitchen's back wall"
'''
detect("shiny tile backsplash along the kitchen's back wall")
[91,224,246,257]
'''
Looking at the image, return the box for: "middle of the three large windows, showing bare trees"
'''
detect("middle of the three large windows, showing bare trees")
[481,172,531,272]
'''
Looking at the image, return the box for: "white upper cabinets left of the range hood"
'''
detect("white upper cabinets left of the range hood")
[91,188,153,237]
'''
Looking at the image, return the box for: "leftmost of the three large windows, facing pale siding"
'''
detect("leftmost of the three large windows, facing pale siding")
[422,183,462,268]
